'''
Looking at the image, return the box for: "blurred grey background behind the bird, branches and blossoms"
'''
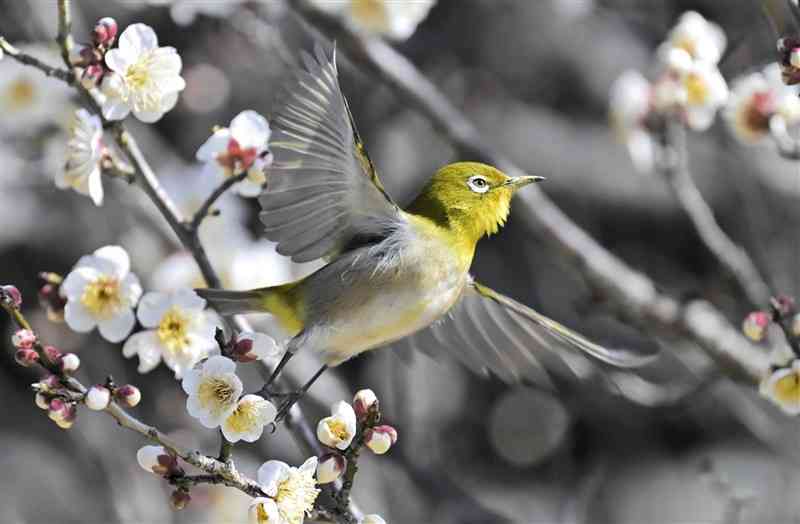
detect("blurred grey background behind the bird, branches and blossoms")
[0,0,800,524]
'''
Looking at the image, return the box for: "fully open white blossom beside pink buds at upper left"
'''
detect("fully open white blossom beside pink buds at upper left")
[98,24,186,123]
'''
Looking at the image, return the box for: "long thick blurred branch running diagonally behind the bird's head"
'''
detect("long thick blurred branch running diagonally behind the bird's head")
[289,0,767,383]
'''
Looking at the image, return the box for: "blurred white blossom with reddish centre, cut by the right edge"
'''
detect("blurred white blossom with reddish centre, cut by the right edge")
[725,63,800,144]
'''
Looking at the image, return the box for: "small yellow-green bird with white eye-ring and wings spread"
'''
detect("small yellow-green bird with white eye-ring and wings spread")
[197,47,649,413]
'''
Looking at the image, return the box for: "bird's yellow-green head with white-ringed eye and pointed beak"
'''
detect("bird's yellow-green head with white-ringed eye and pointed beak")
[410,162,544,242]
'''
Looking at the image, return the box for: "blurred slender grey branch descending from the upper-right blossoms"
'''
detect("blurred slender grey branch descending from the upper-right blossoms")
[656,122,772,309]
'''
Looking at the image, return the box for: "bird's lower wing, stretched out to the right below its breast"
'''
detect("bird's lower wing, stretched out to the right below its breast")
[395,281,655,387]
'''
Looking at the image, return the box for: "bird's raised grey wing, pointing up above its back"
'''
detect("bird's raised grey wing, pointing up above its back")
[259,46,404,262]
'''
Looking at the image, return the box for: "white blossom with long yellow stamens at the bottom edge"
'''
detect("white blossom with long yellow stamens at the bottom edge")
[258,457,320,524]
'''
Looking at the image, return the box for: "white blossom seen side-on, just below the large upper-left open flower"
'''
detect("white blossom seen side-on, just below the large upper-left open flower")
[56,109,104,206]
